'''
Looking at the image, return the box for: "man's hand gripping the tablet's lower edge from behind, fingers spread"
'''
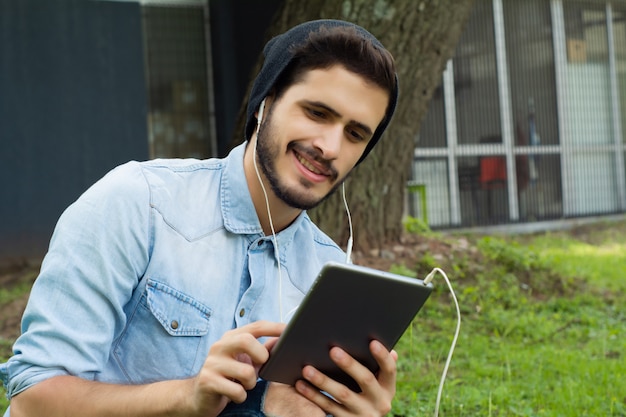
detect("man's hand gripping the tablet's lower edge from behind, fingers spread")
[295,341,398,417]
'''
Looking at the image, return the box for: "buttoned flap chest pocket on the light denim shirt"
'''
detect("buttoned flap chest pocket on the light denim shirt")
[114,279,211,383]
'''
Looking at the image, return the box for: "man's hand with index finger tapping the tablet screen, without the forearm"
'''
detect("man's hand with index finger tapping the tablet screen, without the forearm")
[184,321,285,416]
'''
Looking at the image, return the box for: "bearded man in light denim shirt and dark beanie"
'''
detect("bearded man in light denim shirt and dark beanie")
[0,20,397,417]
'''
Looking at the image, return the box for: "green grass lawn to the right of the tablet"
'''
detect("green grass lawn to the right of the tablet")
[392,227,626,417]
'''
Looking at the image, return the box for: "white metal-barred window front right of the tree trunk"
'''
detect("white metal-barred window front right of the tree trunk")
[408,0,626,228]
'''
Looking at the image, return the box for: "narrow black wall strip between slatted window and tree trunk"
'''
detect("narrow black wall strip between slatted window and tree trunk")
[209,0,281,156]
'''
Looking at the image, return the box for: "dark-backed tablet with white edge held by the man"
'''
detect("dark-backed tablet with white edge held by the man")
[259,262,433,392]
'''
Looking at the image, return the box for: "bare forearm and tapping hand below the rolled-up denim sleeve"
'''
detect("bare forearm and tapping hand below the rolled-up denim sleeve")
[11,321,285,417]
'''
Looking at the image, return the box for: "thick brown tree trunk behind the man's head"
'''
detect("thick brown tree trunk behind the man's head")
[230,0,474,250]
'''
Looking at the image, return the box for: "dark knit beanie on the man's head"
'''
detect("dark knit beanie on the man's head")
[244,19,398,164]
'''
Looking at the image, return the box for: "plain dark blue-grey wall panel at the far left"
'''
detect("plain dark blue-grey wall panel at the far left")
[0,0,148,260]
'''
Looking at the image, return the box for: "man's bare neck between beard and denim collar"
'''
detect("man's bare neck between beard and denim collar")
[244,138,302,235]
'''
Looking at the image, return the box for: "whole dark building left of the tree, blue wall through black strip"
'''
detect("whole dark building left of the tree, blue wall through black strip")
[0,0,279,262]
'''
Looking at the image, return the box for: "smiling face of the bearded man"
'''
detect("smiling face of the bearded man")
[252,66,389,210]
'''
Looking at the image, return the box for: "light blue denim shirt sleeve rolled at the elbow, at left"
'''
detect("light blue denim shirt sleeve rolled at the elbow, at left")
[0,162,151,397]
